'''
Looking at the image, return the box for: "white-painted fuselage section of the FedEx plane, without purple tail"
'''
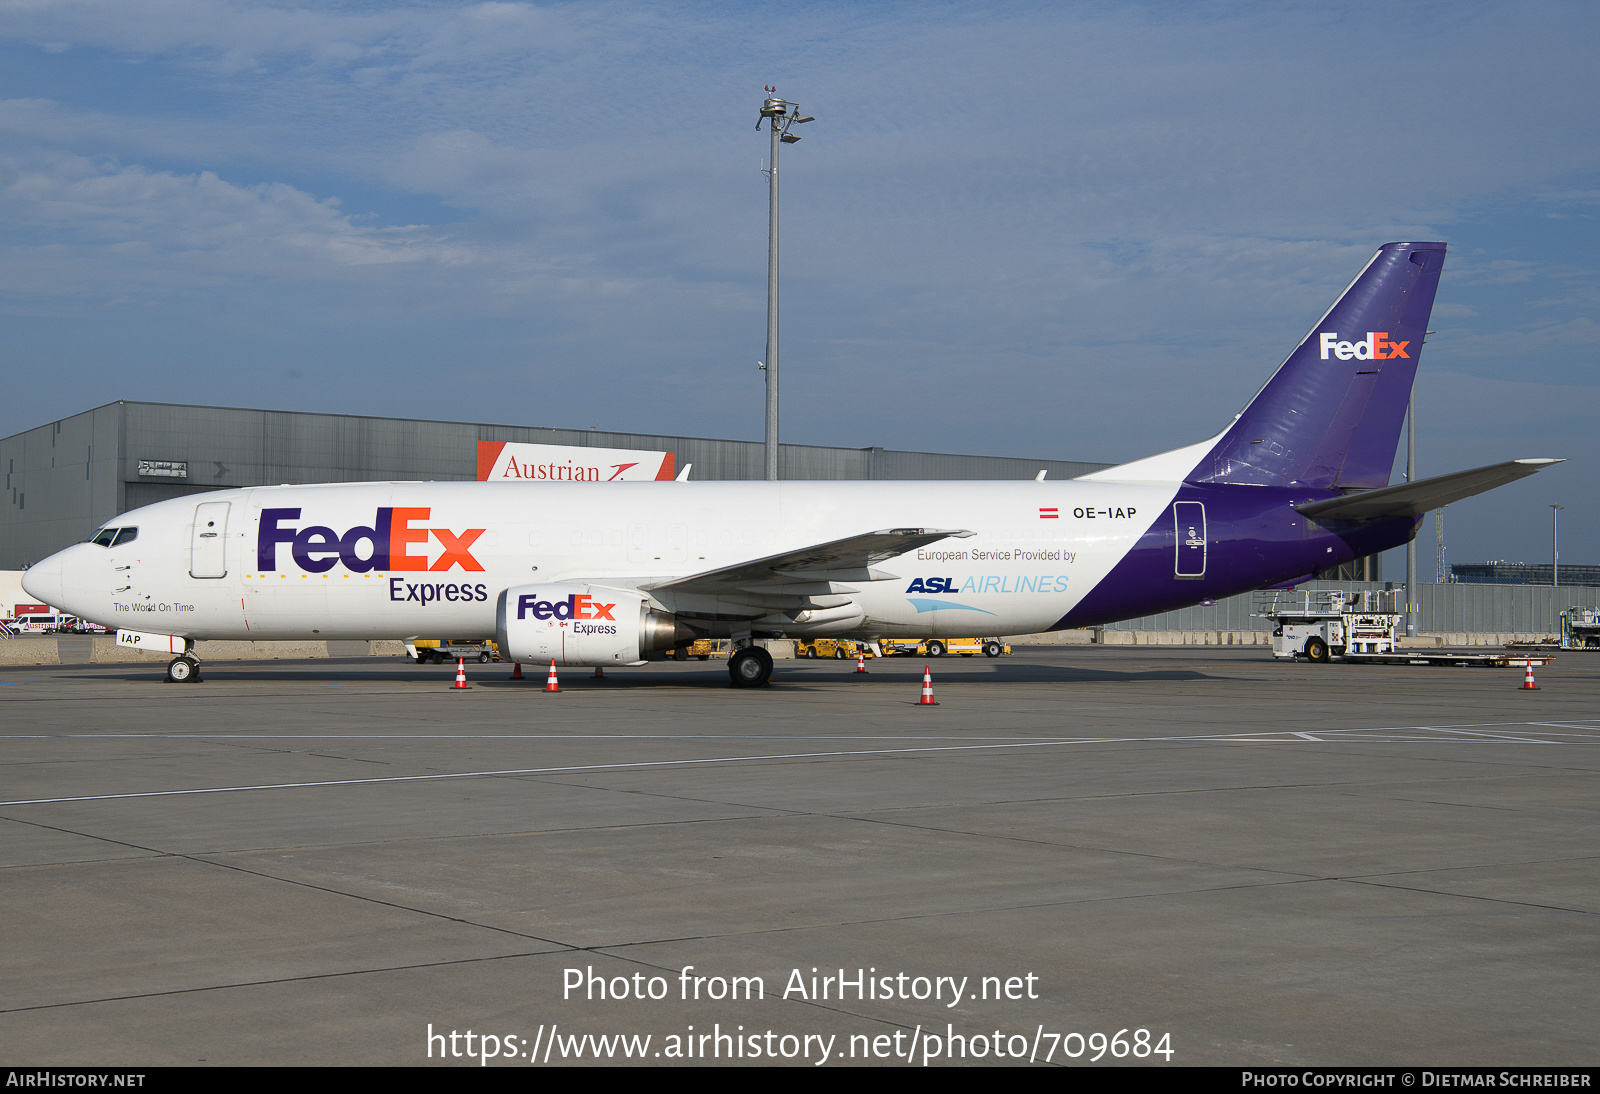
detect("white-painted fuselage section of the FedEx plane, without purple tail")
[29,481,1178,638]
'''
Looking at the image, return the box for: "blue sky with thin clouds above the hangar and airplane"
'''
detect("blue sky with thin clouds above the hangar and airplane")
[0,0,1600,577]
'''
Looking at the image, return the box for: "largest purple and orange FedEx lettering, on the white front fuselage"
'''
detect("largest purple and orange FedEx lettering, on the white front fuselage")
[256,505,488,574]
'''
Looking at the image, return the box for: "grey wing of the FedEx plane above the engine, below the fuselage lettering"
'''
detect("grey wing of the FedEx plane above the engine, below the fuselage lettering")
[643,528,976,600]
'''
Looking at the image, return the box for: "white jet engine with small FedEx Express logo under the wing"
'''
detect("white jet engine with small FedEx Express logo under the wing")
[494,584,688,665]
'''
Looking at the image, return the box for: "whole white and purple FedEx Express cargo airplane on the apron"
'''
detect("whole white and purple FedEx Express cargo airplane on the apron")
[22,243,1560,688]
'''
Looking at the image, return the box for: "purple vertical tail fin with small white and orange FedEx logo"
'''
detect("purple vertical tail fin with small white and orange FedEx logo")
[1187,243,1445,488]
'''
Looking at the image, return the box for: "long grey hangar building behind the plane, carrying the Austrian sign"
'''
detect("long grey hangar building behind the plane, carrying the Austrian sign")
[0,401,1110,571]
